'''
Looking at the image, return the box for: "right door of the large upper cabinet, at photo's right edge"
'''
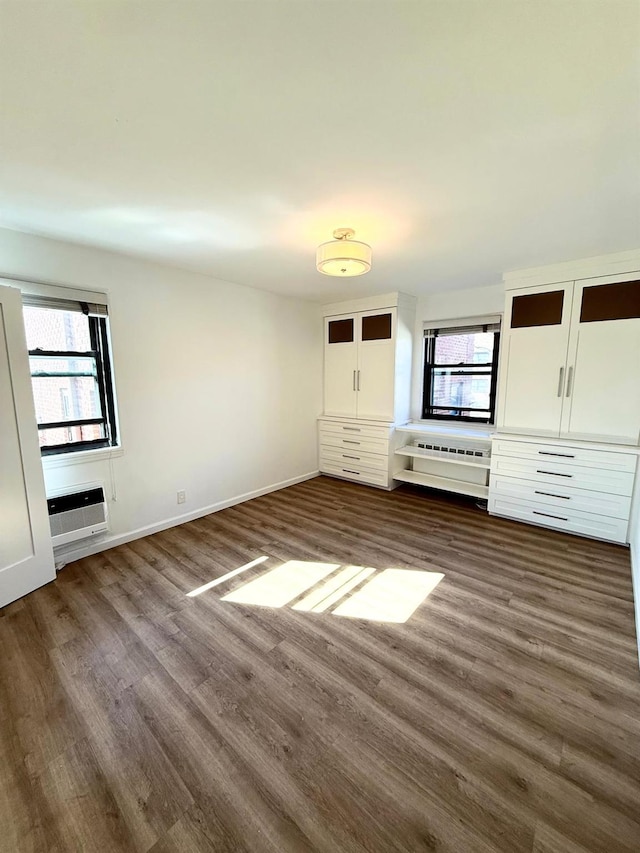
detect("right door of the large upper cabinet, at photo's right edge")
[562,273,640,444]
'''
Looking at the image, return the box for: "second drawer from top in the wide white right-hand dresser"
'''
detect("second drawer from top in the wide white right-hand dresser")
[491,454,635,497]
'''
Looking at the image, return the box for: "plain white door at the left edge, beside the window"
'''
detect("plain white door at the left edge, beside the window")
[0,287,56,607]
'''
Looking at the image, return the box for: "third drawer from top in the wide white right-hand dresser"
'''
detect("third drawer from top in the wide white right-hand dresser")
[489,476,631,521]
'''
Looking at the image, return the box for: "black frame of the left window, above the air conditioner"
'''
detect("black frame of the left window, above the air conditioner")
[28,305,118,457]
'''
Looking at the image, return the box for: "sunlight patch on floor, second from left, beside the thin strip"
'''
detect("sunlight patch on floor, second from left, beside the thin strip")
[222,560,340,607]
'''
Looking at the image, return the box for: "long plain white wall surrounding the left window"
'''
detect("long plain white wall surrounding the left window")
[0,229,322,554]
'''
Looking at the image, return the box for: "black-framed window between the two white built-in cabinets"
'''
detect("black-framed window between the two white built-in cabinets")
[422,322,500,423]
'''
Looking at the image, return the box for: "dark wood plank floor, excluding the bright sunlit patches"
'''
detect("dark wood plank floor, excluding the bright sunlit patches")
[0,478,640,853]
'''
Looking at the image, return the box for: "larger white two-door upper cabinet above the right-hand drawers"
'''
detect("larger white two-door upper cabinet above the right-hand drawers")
[498,274,640,445]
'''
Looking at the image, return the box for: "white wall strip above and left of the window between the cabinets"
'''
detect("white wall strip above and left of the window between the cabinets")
[411,284,504,420]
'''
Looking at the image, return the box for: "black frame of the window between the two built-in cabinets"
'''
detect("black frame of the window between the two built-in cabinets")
[421,324,500,425]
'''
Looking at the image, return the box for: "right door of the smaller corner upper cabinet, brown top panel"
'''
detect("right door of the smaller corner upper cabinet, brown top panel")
[356,308,397,421]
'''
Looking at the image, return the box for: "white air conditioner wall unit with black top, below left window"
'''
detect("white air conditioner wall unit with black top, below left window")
[47,485,109,548]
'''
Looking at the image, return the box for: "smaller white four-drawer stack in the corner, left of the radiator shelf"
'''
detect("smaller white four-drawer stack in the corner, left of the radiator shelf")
[318,418,393,489]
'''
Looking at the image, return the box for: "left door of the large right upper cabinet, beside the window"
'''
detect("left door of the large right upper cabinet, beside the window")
[498,282,573,436]
